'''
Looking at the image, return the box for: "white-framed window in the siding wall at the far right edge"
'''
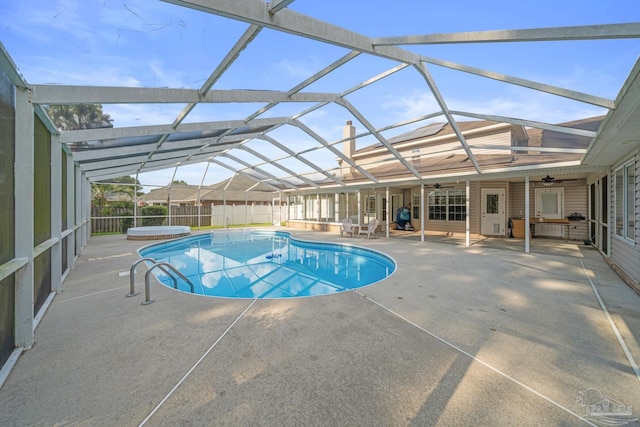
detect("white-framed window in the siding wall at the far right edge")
[615,162,635,240]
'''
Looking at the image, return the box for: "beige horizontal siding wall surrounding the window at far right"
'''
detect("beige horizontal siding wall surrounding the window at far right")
[609,150,640,283]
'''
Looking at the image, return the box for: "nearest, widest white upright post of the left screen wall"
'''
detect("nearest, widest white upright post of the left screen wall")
[13,87,35,349]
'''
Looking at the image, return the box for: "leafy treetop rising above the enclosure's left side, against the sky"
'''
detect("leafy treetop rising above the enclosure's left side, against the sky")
[47,104,113,130]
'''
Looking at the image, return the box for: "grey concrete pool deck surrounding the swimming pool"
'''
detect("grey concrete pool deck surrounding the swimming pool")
[0,228,640,426]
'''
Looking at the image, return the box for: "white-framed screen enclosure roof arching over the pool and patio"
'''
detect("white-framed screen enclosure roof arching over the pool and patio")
[0,0,640,190]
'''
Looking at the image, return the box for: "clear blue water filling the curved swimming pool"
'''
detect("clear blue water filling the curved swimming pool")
[138,231,396,298]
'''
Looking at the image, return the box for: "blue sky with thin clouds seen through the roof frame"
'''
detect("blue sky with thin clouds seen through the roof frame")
[0,0,640,185]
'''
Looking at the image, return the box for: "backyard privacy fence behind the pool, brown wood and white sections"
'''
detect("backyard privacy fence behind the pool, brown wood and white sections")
[91,204,286,233]
